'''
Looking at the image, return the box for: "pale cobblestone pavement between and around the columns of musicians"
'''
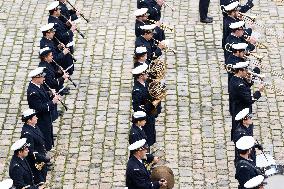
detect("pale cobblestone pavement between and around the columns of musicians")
[0,0,284,189]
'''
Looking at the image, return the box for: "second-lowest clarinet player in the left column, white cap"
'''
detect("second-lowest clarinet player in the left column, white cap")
[39,47,70,95]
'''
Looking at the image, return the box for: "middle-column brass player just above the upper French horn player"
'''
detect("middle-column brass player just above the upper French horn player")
[135,24,165,62]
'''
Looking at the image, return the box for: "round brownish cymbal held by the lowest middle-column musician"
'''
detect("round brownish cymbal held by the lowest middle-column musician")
[151,165,175,189]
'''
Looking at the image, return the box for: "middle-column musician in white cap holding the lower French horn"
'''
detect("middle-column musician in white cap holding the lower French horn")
[132,63,161,146]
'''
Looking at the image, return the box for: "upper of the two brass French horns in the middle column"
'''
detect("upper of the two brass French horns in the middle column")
[148,59,167,81]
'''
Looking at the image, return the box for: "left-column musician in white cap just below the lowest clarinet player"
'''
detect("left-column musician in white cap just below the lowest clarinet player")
[21,109,50,184]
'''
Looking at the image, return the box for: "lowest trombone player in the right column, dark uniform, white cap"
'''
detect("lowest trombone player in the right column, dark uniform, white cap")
[229,62,264,139]
